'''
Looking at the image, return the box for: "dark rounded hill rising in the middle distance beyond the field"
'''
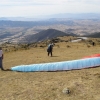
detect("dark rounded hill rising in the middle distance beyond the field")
[21,29,76,43]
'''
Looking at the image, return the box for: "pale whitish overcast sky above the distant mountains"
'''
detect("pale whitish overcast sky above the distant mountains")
[0,0,100,17]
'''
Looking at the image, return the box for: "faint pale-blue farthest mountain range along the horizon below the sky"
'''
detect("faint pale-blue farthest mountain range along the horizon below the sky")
[0,13,100,21]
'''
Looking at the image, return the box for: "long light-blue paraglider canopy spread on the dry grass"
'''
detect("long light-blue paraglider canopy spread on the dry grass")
[11,57,100,72]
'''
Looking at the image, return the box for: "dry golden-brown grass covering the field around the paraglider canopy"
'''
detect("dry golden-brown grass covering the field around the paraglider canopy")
[0,39,100,100]
